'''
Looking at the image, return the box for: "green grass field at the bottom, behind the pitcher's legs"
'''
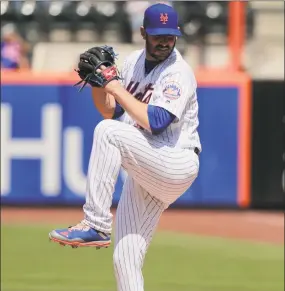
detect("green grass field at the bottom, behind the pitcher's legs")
[1,225,284,291]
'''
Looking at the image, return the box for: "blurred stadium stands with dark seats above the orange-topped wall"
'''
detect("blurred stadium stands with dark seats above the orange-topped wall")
[1,1,284,79]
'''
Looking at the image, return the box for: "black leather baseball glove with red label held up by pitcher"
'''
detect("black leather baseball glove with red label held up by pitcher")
[74,46,120,92]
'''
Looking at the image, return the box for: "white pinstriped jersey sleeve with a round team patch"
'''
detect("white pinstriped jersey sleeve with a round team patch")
[152,72,196,119]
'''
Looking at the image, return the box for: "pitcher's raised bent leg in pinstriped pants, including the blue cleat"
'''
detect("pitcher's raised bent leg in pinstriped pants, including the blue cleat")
[49,120,198,247]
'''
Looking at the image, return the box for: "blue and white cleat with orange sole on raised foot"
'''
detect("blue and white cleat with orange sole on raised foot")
[49,222,111,249]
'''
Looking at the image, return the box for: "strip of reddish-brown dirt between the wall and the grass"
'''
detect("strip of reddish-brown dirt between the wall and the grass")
[1,207,284,244]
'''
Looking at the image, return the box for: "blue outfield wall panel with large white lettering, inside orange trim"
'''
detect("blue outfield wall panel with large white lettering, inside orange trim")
[1,84,239,207]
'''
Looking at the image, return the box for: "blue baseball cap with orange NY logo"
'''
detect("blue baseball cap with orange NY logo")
[143,3,182,36]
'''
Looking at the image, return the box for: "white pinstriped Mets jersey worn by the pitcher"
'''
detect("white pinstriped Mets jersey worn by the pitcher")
[118,49,201,151]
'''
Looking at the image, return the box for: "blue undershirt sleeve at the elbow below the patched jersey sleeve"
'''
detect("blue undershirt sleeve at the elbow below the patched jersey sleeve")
[147,105,176,134]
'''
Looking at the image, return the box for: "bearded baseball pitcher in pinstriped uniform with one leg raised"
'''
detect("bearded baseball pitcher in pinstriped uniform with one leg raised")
[49,3,201,291]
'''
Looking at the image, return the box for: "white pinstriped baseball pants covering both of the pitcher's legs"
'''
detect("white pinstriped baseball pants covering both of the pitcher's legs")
[83,119,199,291]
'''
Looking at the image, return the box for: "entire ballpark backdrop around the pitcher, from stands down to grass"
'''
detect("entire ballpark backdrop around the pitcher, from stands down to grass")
[1,0,285,291]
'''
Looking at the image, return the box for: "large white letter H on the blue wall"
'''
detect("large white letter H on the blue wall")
[1,103,61,196]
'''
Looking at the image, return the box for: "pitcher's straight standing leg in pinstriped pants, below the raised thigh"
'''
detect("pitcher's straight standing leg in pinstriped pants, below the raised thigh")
[113,176,168,291]
